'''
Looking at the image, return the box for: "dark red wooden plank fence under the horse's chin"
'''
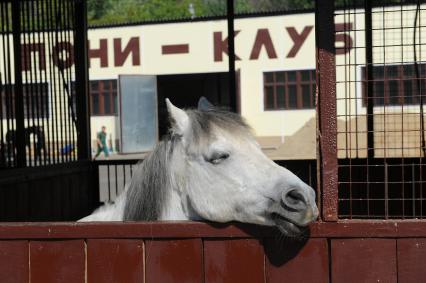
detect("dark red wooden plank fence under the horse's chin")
[0,221,426,283]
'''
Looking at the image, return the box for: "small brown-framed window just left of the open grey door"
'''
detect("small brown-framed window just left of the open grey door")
[89,80,118,116]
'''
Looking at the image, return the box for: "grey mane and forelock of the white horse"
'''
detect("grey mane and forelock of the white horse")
[124,108,250,221]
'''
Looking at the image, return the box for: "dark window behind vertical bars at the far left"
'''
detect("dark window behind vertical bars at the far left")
[0,83,49,119]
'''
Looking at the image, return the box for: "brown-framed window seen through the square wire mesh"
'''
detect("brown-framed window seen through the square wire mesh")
[362,64,426,106]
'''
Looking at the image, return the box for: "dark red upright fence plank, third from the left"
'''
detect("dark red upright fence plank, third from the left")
[87,239,144,283]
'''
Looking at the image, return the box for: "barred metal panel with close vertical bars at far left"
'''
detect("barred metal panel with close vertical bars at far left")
[0,0,78,168]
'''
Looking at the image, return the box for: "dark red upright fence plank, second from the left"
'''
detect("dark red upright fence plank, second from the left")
[30,240,85,283]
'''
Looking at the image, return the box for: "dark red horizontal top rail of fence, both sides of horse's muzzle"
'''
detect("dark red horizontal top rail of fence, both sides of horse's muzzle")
[0,222,426,240]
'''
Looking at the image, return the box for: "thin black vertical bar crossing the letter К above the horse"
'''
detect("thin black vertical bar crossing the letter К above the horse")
[226,0,237,109]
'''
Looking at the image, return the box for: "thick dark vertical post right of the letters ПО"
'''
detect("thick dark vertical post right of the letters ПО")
[73,0,90,160]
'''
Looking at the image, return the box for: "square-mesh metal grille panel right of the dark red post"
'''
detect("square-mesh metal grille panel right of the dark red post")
[334,0,426,219]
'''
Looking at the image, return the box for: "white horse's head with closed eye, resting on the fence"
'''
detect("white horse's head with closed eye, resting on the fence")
[157,98,318,235]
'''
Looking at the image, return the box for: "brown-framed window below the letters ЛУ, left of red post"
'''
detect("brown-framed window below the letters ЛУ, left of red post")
[263,70,315,110]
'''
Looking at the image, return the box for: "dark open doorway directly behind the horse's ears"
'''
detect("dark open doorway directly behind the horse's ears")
[157,72,237,137]
